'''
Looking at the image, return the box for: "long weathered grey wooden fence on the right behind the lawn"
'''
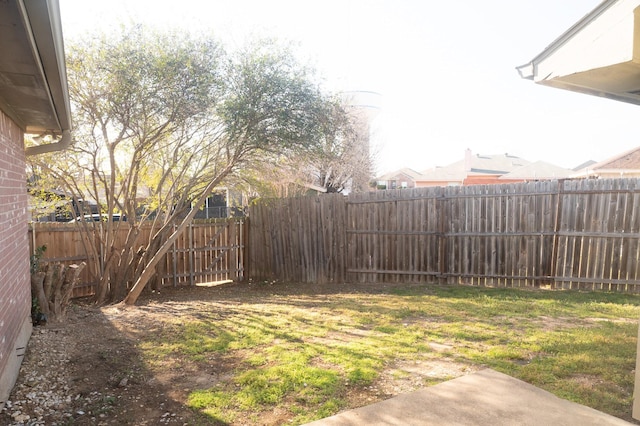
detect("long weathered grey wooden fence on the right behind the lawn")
[248,179,640,293]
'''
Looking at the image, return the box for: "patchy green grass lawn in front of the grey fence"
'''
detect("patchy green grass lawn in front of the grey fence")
[139,283,640,424]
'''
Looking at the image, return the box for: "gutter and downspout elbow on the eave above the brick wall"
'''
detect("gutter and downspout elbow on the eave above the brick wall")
[17,0,72,156]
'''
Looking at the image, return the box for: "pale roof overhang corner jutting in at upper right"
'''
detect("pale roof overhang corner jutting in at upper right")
[517,0,640,105]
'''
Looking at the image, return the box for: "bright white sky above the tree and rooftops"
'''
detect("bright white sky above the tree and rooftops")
[60,0,640,174]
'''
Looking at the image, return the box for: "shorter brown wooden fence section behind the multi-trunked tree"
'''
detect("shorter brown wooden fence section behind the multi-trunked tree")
[29,219,246,297]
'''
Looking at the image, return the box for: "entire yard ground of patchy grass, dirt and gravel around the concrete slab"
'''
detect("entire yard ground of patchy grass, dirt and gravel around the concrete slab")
[0,282,640,425]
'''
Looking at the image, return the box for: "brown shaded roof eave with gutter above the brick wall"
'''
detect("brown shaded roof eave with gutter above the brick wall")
[0,0,71,154]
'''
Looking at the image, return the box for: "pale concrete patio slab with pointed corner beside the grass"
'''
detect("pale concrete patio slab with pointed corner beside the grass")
[308,369,632,426]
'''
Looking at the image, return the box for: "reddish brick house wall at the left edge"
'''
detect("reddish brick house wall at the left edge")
[0,106,31,407]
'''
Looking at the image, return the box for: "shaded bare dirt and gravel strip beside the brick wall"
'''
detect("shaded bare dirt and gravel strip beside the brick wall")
[0,305,192,426]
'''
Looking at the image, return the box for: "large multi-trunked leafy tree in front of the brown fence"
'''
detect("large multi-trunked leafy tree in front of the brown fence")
[28,27,344,303]
